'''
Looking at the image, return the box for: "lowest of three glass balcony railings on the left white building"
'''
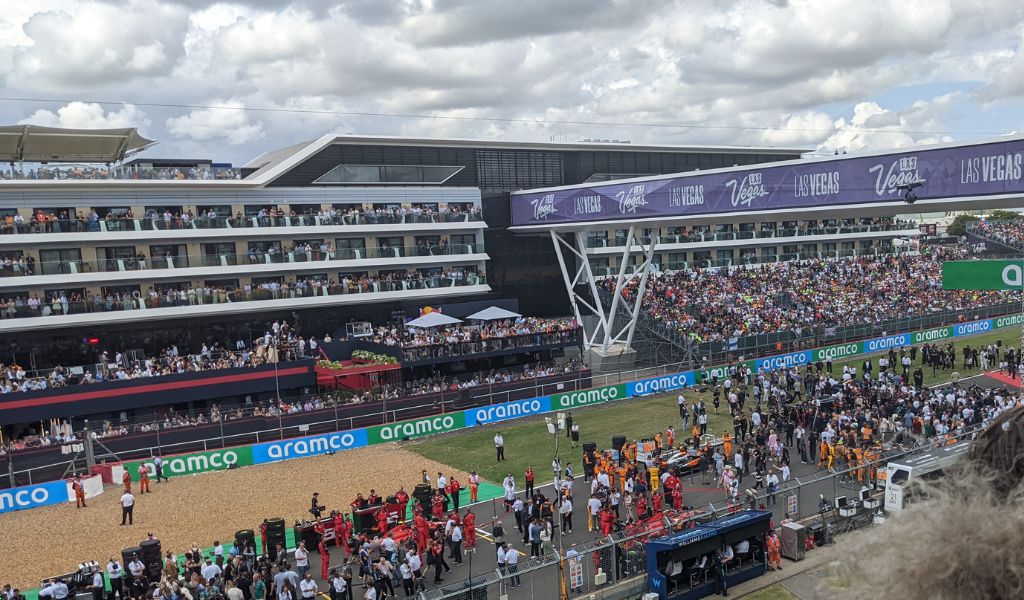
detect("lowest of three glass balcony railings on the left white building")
[0,271,487,318]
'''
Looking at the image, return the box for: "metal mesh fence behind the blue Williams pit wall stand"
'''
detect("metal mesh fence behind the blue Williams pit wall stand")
[418,427,980,600]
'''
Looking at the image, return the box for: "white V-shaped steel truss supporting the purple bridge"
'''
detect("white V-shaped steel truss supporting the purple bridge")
[550,225,656,354]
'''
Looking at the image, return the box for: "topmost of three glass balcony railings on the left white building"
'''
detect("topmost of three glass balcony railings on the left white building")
[0,211,483,234]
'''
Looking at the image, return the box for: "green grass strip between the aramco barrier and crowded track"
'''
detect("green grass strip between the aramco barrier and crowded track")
[406,328,1020,482]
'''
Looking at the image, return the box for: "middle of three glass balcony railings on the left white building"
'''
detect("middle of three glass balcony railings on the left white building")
[0,244,483,277]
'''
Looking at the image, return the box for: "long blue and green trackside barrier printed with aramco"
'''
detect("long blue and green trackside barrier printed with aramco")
[0,314,1024,513]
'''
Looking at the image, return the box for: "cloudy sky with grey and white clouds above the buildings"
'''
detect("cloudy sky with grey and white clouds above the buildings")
[0,0,1024,165]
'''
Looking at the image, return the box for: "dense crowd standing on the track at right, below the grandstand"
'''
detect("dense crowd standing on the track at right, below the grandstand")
[679,343,1022,507]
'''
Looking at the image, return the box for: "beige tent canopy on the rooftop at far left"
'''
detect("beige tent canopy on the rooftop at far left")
[0,125,157,163]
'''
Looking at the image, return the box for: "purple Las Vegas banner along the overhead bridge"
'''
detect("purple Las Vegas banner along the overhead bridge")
[512,138,1024,226]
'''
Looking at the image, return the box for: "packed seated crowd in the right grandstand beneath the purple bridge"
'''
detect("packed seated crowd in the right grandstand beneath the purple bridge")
[601,248,1013,342]
